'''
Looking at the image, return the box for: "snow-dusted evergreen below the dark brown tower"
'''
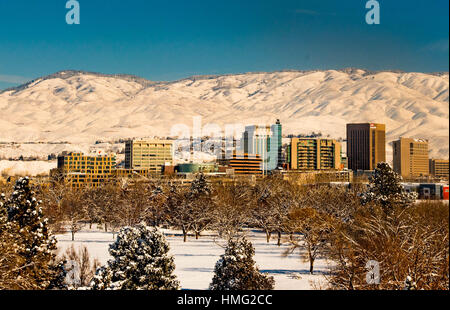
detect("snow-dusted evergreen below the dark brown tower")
[361,162,417,210]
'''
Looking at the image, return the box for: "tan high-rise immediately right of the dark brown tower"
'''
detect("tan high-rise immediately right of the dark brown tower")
[392,137,429,178]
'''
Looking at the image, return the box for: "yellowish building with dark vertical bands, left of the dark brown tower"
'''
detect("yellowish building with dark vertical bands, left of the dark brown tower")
[289,138,341,170]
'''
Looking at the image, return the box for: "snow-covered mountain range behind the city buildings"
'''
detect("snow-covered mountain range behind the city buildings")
[0,69,449,157]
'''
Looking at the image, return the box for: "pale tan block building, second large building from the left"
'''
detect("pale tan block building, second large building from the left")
[125,140,174,174]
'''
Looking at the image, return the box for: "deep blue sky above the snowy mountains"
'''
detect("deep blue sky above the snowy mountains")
[0,0,449,89]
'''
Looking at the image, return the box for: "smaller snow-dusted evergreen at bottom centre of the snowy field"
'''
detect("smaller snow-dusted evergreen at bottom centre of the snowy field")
[209,238,275,290]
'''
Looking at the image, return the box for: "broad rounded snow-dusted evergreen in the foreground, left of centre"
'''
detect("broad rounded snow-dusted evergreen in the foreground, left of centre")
[91,224,179,290]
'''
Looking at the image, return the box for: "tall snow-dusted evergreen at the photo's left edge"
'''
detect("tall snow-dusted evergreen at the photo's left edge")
[2,177,63,289]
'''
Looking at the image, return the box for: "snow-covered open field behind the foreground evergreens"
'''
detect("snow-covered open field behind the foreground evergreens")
[57,230,330,290]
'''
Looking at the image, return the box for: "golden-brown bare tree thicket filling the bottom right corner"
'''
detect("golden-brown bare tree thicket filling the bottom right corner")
[330,203,449,289]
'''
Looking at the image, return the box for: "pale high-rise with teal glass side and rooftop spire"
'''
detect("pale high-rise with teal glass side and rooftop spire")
[241,120,283,172]
